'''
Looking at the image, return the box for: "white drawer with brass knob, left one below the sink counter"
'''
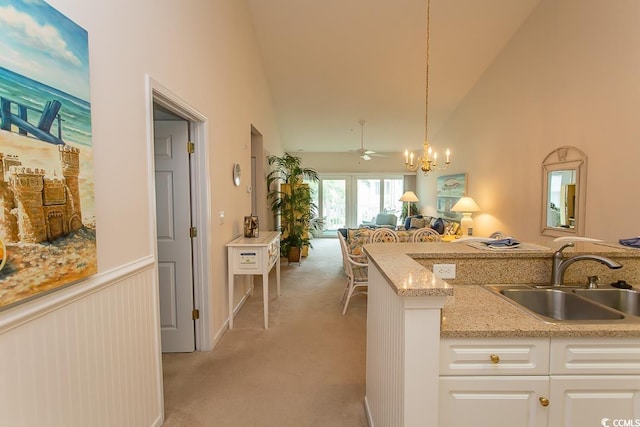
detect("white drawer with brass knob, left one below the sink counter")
[440,338,549,375]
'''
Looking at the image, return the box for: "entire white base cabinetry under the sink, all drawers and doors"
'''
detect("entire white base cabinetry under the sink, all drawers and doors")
[439,338,640,427]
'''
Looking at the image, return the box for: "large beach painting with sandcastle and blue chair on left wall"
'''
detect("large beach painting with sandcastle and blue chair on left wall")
[0,0,97,309]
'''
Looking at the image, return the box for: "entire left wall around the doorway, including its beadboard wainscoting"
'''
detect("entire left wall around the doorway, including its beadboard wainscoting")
[0,0,282,425]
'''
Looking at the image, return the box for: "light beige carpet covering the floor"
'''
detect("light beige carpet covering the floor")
[163,239,367,427]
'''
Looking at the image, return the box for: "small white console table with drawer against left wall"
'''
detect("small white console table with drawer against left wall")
[227,231,280,329]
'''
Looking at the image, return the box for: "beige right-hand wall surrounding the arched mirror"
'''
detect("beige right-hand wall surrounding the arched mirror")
[418,0,640,244]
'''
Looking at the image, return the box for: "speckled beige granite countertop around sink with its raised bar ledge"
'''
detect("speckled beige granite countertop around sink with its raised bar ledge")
[364,242,640,338]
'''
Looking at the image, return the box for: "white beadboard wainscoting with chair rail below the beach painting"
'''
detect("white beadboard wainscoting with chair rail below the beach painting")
[0,257,163,427]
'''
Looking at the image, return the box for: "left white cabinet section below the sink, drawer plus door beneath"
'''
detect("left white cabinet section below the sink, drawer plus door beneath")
[438,338,549,427]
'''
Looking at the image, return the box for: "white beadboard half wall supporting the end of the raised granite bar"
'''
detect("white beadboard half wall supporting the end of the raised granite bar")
[365,262,446,427]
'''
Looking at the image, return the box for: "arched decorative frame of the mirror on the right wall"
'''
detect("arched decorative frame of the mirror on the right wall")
[541,146,587,237]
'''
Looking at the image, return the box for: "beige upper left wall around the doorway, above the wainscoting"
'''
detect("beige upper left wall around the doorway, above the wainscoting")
[45,0,281,342]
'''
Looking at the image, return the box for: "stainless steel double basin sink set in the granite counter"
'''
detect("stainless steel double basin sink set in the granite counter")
[484,285,640,323]
